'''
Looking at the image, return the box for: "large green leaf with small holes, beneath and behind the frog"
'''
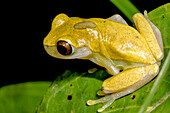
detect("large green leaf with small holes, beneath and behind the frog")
[37,4,170,113]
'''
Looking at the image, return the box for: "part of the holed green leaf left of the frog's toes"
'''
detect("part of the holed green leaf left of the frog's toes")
[37,70,108,113]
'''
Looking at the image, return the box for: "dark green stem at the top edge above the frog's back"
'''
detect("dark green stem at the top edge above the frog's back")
[110,0,140,23]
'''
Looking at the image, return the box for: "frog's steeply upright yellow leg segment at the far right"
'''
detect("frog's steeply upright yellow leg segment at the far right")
[133,13,163,61]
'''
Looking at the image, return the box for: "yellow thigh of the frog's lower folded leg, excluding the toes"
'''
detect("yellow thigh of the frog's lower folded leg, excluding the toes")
[102,64,159,94]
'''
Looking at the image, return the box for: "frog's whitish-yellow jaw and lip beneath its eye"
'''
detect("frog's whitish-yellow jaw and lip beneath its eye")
[44,45,92,59]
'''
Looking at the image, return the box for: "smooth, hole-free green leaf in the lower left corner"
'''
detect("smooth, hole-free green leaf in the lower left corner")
[0,82,50,113]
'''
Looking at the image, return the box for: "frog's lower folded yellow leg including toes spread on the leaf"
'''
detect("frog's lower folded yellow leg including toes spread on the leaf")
[87,64,159,112]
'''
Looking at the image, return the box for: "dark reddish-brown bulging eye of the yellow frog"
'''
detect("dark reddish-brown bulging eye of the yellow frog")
[57,40,72,55]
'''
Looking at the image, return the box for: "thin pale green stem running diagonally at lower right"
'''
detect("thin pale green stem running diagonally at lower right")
[139,51,170,113]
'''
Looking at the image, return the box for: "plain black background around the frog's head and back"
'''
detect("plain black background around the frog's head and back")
[0,0,167,87]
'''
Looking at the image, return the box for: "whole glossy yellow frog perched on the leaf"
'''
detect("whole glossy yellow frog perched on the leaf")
[43,12,164,112]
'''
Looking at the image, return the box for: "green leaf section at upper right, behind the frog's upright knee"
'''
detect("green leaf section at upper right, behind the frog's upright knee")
[148,3,170,57]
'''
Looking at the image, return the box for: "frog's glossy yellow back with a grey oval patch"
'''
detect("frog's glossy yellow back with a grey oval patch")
[59,17,156,64]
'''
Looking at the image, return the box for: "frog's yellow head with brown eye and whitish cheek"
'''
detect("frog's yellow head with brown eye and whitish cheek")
[44,14,92,59]
